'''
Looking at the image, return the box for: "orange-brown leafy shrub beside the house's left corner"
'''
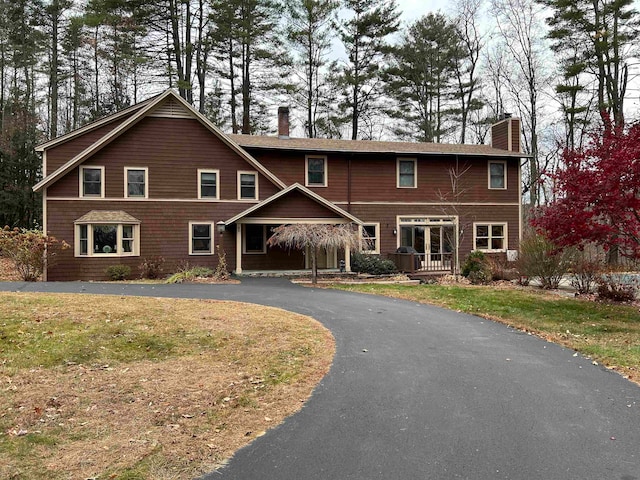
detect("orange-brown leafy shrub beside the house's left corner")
[0,227,69,282]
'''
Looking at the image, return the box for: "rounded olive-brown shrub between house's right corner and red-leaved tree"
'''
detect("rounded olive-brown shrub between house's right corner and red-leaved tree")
[517,233,575,289]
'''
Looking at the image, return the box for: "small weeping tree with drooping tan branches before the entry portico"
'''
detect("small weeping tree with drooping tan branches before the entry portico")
[267,223,363,284]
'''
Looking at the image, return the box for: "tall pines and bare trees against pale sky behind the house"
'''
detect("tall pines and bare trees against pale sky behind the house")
[0,0,639,227]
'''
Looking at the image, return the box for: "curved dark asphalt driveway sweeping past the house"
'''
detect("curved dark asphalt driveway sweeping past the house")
[0,279,640,480]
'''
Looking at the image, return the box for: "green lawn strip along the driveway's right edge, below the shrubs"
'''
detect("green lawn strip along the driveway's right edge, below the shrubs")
[333,284,640,374]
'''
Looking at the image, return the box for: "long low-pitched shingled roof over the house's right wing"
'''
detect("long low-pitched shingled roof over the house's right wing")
[228,135,529,158]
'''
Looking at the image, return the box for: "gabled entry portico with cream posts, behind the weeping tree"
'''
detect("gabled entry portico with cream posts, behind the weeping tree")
[221,183,362,275]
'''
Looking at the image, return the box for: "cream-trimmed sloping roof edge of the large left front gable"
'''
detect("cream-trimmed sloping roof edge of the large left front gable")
[33,89,286,191]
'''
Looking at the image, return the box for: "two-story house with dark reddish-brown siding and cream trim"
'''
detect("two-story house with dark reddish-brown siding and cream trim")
[34,90,524,280]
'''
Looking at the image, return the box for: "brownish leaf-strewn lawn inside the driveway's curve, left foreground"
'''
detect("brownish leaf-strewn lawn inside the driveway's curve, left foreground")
[0,293,334,479]
